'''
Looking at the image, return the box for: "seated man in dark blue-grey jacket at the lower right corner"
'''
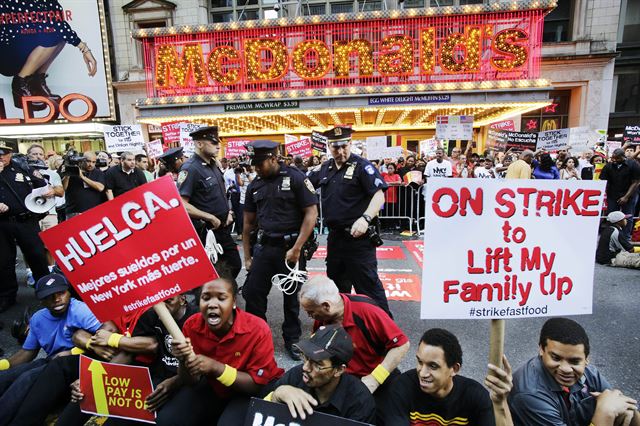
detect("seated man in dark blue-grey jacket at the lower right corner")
[509,318,640,426]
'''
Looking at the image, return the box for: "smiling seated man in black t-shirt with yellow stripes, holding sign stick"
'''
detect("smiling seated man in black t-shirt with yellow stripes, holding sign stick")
[378,328,513,426]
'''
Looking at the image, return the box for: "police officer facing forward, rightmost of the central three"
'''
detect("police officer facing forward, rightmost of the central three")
[310,127,391,315]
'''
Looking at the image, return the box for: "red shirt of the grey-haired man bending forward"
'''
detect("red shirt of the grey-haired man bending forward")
[313,294,409,377]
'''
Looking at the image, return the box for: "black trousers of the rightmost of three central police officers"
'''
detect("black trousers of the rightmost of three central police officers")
[327,230,391,316]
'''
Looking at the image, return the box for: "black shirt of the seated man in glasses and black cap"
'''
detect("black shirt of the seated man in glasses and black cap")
[264,365,376,423]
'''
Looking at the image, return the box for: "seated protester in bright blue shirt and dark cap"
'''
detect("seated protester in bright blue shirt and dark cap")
[0,274,100,425]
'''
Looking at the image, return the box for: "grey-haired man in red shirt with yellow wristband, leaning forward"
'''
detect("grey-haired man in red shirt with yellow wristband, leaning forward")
[300,276,410,393]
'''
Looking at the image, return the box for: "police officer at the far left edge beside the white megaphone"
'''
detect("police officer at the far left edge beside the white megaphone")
[0,142,55,312]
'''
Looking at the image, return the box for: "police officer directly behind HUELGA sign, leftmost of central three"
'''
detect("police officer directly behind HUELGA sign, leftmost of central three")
[178,126,242,279]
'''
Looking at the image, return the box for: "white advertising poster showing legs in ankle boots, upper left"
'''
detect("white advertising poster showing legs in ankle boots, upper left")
[0,0,115,121]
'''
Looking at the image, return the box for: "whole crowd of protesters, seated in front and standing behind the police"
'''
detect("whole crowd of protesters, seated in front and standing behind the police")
[0,131,640,426]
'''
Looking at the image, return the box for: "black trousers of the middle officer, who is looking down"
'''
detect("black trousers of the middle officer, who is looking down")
[242,244,306,344]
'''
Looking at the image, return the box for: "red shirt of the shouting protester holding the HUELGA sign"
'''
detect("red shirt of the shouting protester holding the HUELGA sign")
[182,309,284,398]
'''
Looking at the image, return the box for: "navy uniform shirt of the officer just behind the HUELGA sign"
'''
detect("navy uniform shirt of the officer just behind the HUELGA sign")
[178,154,229,221]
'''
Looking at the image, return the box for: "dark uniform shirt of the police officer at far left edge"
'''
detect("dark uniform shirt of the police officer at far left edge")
[0,161,47,217]
